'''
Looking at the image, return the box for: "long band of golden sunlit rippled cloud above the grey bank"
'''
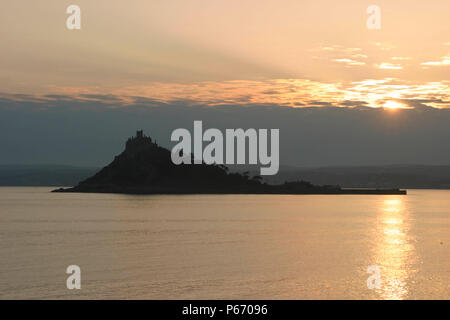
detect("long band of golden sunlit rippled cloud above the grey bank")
[0,77,450,108]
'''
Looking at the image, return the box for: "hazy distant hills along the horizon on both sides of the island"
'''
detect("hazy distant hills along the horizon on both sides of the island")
[0,165,450,189]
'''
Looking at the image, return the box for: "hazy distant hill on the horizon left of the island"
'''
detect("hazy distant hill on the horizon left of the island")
[0,165,99,187]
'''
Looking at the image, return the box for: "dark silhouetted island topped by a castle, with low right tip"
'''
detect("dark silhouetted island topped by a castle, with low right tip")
[53,131,406,195]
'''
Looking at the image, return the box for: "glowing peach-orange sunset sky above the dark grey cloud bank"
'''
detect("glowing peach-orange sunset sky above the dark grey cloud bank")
[0,0,450,108]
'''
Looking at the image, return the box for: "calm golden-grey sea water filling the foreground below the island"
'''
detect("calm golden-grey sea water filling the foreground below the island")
[0,188,450,299]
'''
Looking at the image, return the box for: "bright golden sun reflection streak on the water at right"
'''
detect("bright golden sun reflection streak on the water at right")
[375,196,414,300]
